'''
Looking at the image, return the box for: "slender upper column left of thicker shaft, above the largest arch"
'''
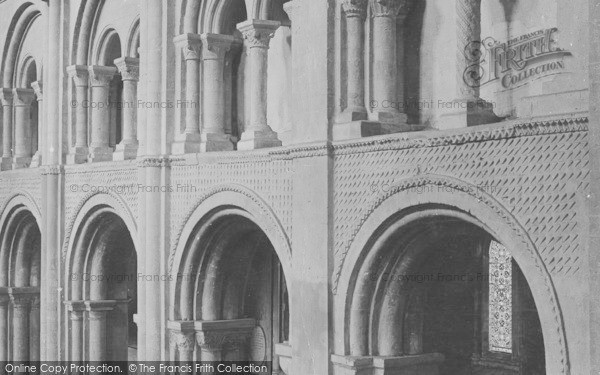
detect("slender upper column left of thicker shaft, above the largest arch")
[337,0,367,122]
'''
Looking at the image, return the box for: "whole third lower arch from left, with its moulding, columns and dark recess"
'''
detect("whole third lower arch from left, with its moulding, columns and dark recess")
[169,186,291,366]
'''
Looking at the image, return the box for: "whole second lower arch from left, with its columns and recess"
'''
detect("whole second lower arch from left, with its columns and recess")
[64,194,138,361]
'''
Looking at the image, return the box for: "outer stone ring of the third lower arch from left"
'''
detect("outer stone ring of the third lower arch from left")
[169,186,292,319]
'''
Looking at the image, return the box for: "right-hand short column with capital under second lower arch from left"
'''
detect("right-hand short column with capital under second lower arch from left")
[85,301,116,361]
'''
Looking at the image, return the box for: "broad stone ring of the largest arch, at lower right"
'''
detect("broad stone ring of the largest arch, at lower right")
[333,175,570,374]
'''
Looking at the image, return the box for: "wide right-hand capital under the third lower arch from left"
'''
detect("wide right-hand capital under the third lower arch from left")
[194,319,256,351]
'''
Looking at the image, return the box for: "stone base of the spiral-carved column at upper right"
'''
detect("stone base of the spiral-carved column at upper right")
[436,99,502,129]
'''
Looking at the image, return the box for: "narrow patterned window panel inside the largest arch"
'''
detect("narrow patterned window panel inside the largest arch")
[489,241,512,353]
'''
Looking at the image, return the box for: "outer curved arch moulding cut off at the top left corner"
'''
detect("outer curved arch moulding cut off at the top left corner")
[2,2,42,88]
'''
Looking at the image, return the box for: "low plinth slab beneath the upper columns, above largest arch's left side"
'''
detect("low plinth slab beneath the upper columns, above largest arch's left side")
[333,121,425,141]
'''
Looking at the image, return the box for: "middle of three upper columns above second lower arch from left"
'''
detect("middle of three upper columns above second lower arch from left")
[89,66,117,162]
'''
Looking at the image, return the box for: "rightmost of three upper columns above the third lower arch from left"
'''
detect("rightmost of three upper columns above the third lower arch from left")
[237,20,281,150]
